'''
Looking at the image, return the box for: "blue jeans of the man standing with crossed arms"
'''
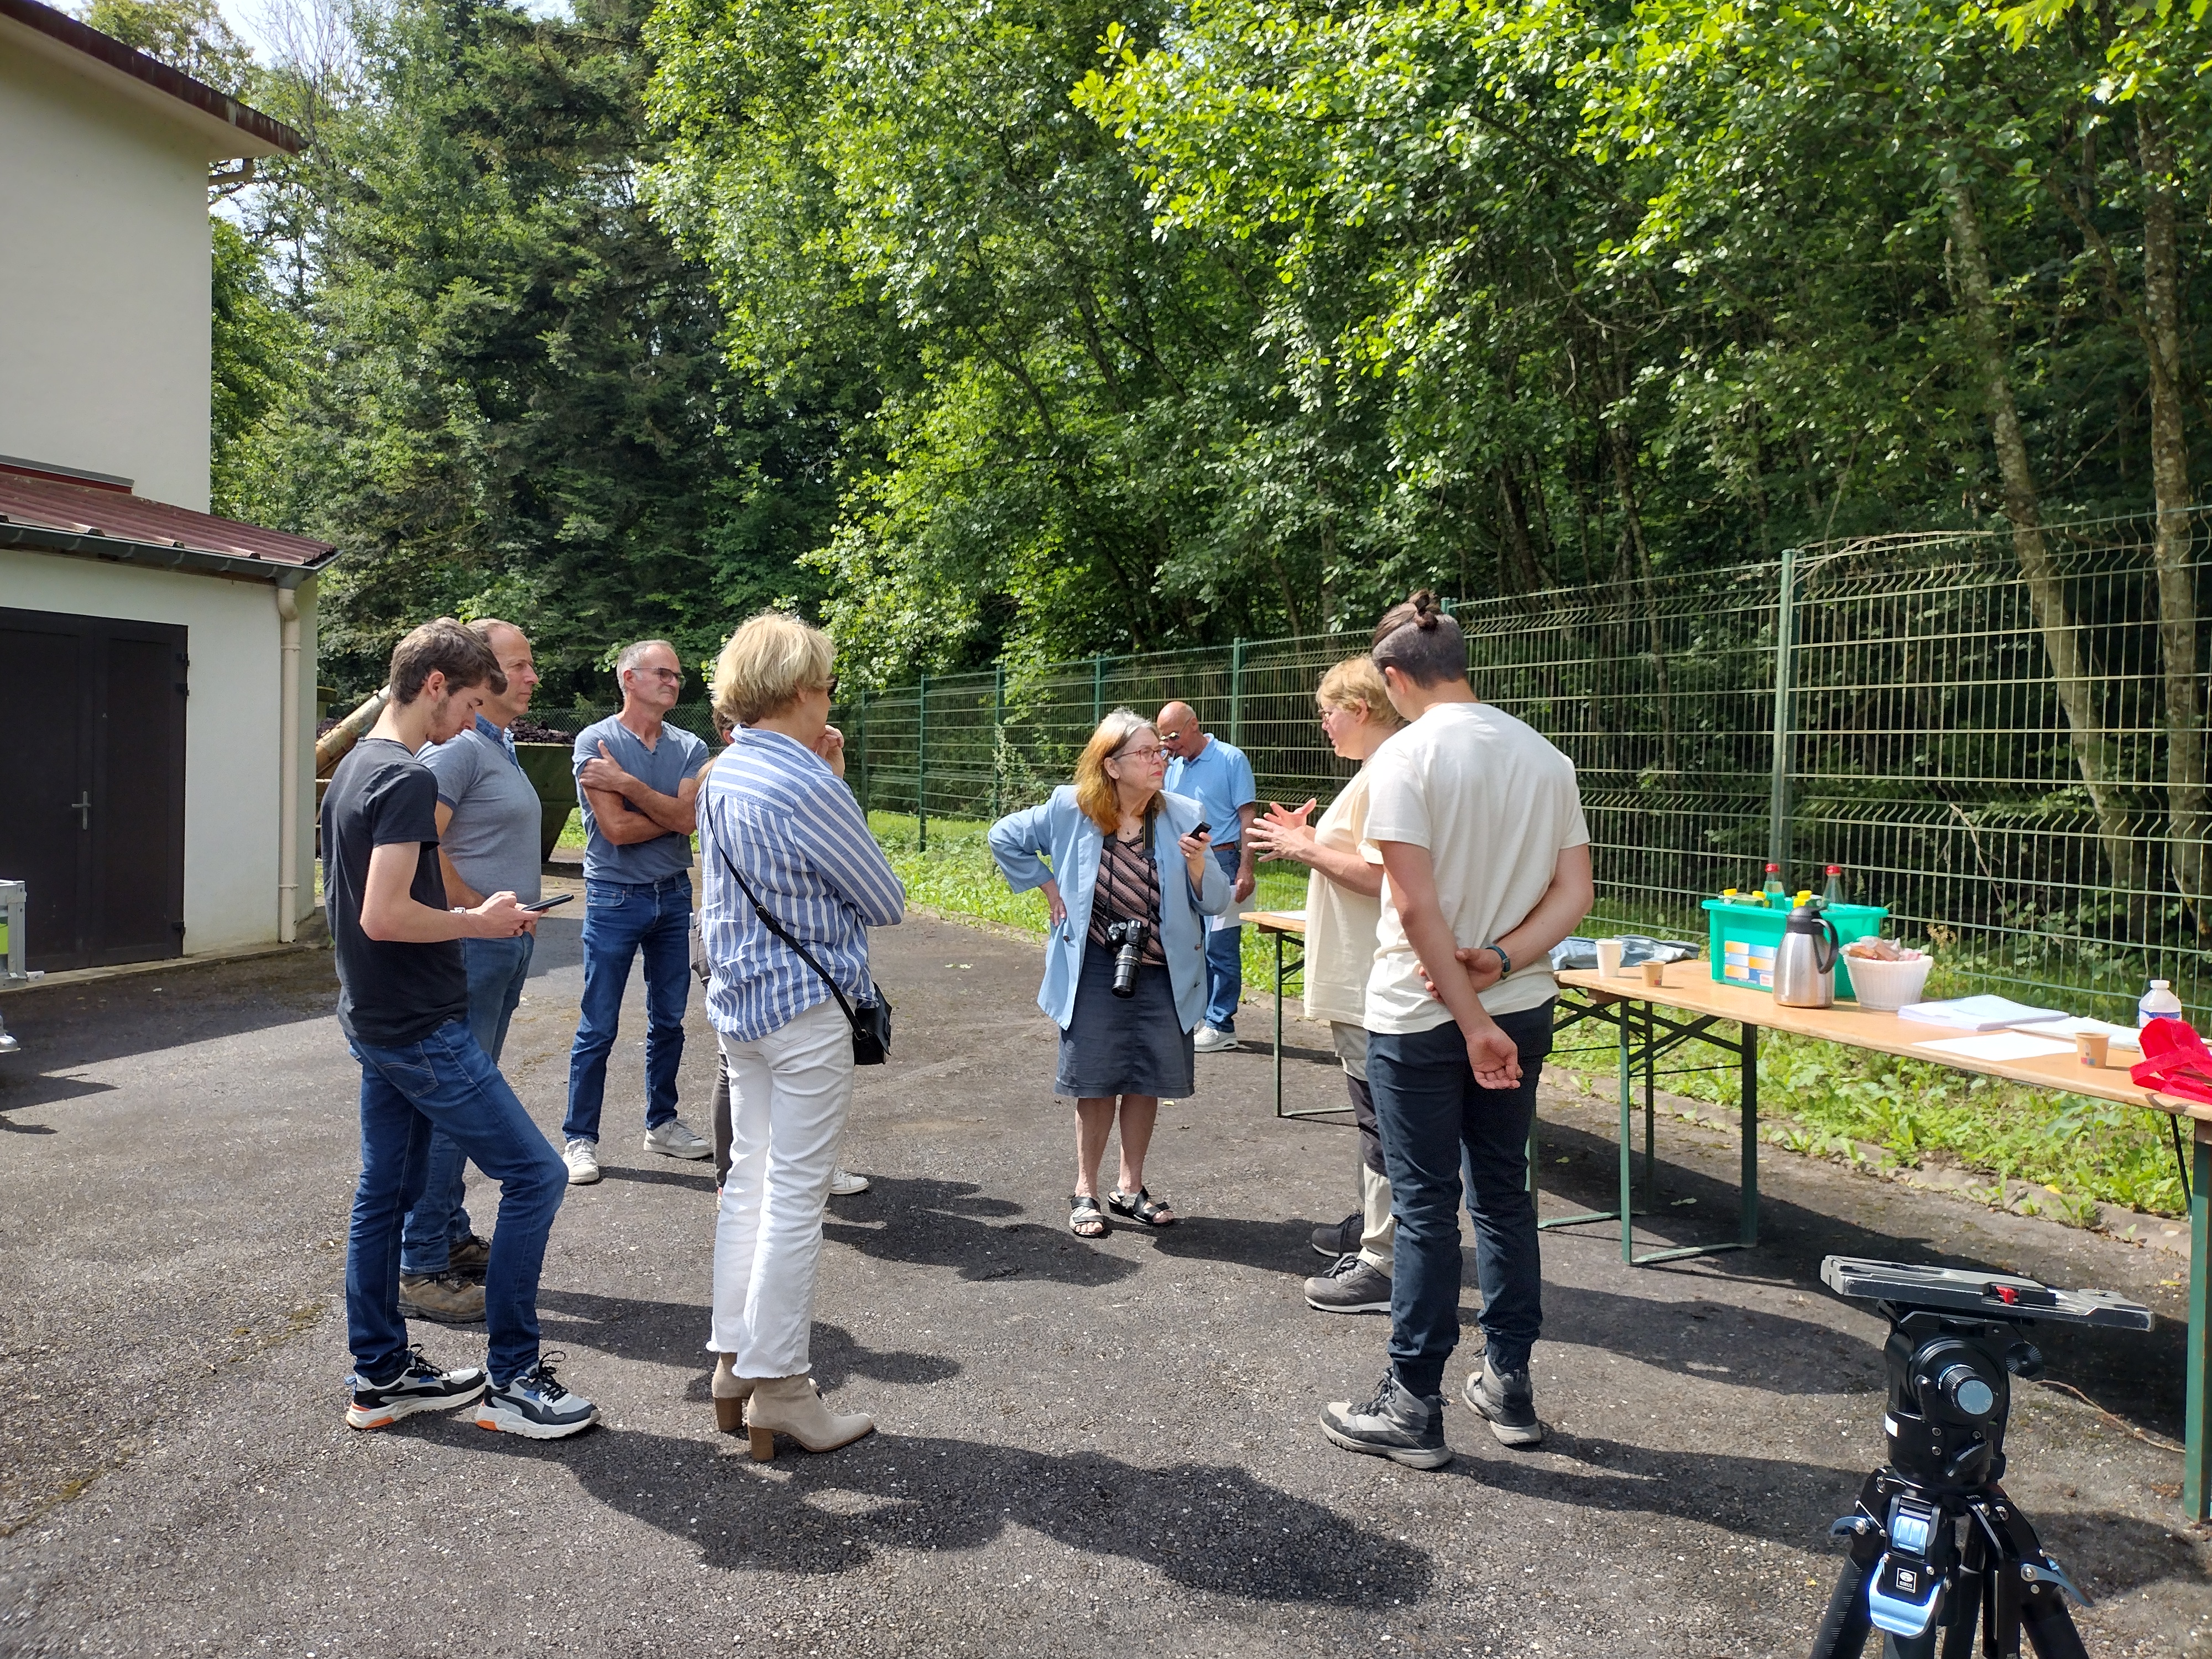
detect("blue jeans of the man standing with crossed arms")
[560,876,690,1141]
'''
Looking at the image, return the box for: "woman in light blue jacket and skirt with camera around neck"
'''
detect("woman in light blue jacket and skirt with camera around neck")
[991,708,1230,1239]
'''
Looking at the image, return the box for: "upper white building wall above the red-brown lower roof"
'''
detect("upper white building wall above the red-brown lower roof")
[0,42,212,507]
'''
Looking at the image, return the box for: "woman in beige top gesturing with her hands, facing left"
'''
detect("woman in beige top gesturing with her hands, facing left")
[1250,657,1400,1314]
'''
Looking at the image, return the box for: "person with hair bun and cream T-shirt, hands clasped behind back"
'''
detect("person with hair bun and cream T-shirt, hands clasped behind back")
[1321,588,1593,1469]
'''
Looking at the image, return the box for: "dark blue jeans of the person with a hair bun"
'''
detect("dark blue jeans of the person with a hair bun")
[1367,1002,1553,1398]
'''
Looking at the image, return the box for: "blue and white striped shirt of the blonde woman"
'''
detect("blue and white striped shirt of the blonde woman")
[699,726,907,1042]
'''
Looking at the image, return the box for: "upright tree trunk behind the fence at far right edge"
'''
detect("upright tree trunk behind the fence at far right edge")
[2135,97,2212,938]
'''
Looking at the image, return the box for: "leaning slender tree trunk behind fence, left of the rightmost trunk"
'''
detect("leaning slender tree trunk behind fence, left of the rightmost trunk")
[1947,181,2150,938]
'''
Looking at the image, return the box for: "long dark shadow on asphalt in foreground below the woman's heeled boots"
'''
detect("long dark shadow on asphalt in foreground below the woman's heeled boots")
[460,1418,1436,1606]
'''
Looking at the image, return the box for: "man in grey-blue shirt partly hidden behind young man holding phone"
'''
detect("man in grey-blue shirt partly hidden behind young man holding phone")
[400,617,542,1325]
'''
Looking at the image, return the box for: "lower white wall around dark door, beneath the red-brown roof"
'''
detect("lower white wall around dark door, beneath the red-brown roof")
[0,549,316,956]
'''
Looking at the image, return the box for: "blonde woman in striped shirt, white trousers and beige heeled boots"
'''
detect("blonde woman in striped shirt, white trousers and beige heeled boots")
[699,611,907,1460]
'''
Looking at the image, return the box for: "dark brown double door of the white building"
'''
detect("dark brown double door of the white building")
[0,608,188,969]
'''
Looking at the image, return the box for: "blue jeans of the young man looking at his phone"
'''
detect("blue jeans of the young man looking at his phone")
[345,1020,568,1383]
